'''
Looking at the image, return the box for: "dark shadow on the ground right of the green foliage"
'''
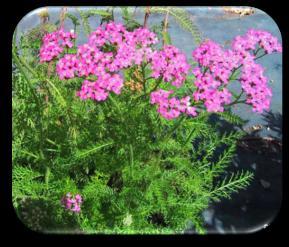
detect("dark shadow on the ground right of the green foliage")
[187,112,282,233]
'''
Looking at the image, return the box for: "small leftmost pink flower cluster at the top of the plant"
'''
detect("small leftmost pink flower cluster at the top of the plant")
[40,29,76,63]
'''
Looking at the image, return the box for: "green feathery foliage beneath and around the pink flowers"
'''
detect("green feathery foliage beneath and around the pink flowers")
[12,7,253,234]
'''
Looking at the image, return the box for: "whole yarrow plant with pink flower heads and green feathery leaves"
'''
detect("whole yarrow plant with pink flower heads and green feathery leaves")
[12,7,282,233]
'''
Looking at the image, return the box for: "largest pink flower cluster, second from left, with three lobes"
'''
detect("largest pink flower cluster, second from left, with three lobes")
[52,22,158,101]
